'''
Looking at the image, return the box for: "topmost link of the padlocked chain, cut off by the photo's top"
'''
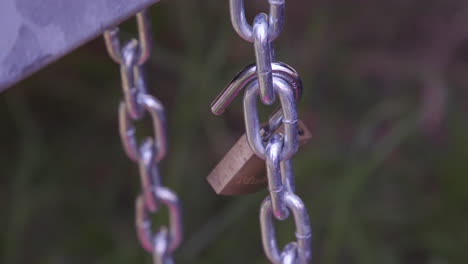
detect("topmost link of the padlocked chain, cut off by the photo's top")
[229,0,285,42]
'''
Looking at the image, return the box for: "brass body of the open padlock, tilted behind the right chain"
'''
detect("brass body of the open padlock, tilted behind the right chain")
[207,120,312,195]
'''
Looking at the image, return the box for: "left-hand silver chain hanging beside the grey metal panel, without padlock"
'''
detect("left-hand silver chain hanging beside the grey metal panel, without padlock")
[104,11,182,264]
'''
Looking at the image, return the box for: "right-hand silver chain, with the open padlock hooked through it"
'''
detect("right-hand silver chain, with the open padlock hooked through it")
[229,0,312,264]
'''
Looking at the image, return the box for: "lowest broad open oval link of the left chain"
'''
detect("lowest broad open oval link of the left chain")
[135,187,182,254]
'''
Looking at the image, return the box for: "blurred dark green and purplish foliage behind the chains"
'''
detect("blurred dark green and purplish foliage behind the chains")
[0,0,468,264]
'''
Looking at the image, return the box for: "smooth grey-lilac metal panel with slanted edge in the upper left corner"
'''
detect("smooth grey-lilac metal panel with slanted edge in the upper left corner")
[0,0,159,91]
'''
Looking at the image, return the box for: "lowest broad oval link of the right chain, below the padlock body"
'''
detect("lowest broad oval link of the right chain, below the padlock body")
[260,192,312,264]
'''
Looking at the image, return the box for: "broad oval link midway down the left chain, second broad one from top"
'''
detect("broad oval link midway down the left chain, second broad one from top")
[119,94,167,162]
